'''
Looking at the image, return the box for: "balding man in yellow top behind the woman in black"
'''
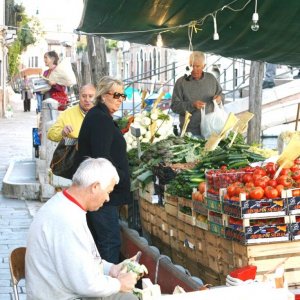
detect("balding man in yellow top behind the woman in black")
[47,84,96,142]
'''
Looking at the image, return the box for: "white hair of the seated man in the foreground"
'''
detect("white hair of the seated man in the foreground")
[72,158,120,189]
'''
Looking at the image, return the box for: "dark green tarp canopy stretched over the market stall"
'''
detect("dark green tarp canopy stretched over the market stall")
[78,0,300,67]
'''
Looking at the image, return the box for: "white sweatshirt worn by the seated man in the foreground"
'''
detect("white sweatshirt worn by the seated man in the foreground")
[25,193,120,300]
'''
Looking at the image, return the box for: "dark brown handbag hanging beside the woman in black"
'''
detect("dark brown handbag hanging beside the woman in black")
[50,138,78,179]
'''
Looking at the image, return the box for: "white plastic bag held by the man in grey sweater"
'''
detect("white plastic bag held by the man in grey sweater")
[200,100,228,139]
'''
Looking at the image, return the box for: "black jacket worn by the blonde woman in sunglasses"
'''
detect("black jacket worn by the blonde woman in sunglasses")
[76,104,131,205]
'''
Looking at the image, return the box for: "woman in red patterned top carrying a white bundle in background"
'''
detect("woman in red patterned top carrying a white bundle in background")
[43,51,68,110]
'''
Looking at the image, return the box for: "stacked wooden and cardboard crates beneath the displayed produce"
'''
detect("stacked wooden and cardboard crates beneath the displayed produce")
[139,185,300,287]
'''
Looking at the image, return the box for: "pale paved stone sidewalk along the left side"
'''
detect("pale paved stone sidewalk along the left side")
[0,94,42,300]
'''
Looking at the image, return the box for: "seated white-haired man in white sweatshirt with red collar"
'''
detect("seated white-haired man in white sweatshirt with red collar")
[25,158,137,300]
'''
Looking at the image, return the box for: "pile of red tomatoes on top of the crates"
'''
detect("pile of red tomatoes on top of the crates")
[206,158,300,201]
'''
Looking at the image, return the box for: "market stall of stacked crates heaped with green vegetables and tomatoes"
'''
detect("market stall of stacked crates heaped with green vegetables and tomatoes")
[120,108,300,288]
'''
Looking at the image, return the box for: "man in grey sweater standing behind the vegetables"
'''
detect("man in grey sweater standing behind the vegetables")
[171,51,224,136]
